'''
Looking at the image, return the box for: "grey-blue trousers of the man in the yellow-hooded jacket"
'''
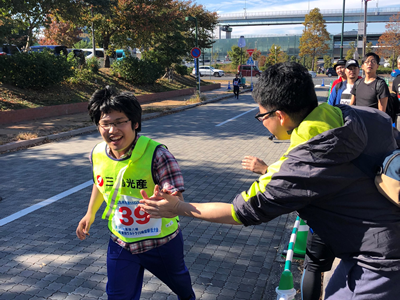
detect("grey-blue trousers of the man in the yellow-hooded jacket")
[325,260,400,300]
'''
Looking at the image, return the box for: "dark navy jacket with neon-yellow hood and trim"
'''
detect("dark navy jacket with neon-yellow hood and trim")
[232,103,400,271]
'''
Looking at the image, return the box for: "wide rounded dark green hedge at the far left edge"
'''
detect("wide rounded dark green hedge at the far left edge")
[0,51,74,89]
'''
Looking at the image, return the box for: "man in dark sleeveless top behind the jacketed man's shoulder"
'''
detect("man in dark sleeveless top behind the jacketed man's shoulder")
[350,52,390,112]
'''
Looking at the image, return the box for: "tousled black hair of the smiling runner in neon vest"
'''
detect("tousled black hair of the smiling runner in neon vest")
[88,86,142,132]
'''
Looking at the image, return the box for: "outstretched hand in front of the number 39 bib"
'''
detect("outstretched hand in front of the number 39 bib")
[139,185,181,218]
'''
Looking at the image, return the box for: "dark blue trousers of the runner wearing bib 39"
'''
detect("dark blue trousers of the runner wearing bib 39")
[106,232,196,300]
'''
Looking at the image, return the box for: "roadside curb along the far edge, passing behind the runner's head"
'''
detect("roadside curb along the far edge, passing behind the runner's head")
[0,89,251,153]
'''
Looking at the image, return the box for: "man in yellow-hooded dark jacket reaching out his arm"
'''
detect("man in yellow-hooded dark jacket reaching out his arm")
[140,62,400,300]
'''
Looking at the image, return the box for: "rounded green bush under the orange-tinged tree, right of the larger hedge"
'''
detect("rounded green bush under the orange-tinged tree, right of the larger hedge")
[112,57,165,85]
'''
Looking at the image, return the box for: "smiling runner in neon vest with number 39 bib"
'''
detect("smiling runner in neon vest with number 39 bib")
[76,87,196,300]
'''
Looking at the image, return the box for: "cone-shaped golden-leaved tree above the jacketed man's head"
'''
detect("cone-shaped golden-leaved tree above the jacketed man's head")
[300,8,330,69]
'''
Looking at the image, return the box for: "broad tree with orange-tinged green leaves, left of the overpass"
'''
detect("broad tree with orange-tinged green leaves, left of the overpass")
[66,0,217,67]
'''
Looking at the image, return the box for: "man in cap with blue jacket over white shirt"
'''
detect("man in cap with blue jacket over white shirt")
[328,59,360,105]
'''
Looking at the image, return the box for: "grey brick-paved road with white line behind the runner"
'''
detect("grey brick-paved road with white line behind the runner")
[0,94,299,300]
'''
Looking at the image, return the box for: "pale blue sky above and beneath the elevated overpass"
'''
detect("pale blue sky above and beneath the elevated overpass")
[195,0,400,36]
